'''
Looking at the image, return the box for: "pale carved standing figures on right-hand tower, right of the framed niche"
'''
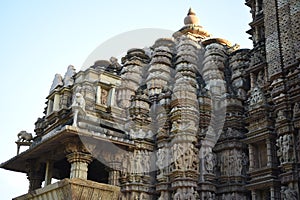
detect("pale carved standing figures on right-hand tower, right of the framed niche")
[276,135,294,164]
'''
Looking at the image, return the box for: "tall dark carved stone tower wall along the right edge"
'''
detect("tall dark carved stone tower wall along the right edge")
[244,0,300,199]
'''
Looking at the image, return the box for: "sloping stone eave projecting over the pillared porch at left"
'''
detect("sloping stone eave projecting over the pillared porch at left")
[0,126,134,173]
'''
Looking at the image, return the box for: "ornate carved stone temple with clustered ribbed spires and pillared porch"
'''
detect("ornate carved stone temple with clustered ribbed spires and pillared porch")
[0,0,300,200]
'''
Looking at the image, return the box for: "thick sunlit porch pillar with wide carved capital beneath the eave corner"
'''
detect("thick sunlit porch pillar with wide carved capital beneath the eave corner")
[67,152,93,179]
